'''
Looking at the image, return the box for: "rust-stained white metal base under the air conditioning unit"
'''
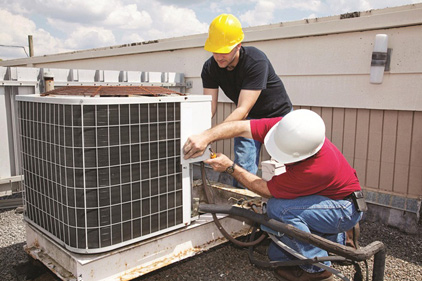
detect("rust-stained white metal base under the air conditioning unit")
[24,214,254,281]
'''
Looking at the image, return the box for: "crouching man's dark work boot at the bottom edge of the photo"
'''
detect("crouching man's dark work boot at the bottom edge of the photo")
[274,266,334,281]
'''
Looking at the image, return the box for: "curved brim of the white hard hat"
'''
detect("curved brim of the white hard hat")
[264,121,324,164]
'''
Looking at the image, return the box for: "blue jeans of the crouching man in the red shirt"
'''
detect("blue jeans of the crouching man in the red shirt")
[267,195,362,273]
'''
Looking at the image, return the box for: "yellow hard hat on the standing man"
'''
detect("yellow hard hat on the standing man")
[204,14,244,54]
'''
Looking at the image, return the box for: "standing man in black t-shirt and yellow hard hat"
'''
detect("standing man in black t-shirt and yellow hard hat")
[201,14,292,187]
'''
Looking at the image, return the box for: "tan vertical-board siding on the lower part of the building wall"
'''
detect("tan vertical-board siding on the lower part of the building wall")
[213,104,422,197]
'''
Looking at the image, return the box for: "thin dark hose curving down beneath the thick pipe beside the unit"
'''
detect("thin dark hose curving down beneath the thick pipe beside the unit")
[199,162,267,247]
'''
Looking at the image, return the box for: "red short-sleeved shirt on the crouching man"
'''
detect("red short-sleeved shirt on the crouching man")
[251,117,361,200]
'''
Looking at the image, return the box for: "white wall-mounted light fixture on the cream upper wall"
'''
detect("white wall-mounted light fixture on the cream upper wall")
[370,34,391,84]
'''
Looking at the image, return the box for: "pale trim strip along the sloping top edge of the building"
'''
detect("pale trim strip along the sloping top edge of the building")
[0,3,422,66]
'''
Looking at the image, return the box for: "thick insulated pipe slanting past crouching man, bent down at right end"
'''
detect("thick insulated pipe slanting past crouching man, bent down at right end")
[199,201,385,281]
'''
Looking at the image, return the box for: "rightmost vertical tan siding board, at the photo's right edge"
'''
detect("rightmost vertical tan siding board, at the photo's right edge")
[407,112,422,197]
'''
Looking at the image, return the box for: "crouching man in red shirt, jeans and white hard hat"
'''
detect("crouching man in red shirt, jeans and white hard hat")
[183,109,364,281]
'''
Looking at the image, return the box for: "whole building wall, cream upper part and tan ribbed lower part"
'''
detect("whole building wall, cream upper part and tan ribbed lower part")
[0,4,422,228]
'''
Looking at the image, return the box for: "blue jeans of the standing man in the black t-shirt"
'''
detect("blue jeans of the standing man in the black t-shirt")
[233,137,261,187]
